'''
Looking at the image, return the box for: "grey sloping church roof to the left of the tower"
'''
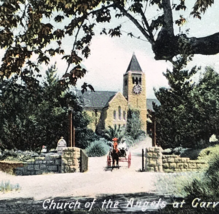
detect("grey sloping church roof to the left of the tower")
[77,90,117,109]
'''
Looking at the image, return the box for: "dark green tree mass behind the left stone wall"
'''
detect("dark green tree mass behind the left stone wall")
[0,66,93,150]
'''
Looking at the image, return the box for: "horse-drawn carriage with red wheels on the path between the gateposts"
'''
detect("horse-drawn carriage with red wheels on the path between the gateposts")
[107,140,131,168]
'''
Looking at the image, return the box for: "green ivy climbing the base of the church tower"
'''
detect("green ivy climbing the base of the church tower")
[125,109,145,140]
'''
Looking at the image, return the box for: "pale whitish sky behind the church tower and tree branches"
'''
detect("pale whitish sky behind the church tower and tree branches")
[0,0,219,98]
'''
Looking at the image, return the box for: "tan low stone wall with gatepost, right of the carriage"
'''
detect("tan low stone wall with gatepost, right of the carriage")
[145,147,207,172]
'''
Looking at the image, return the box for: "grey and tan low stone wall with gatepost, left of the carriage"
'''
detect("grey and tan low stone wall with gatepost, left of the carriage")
[0,147,88,175]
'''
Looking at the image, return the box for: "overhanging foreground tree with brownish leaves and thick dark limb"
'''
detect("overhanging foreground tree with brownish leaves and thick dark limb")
[0,0,219,83]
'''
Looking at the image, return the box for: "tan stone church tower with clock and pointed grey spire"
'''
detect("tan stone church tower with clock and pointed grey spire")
[123,54,147,132]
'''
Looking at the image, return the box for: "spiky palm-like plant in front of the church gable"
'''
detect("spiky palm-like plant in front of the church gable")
[103,126,125,142]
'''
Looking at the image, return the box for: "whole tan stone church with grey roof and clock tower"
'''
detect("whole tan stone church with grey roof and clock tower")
[77,54,159,133]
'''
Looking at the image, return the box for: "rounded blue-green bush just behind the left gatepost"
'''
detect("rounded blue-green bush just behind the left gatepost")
[85,139,110,157]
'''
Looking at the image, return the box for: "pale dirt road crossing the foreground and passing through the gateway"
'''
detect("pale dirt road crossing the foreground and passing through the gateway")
[0,138,159,200]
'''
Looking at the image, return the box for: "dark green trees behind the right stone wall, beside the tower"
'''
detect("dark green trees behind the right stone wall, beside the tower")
[151,57,219,148]
